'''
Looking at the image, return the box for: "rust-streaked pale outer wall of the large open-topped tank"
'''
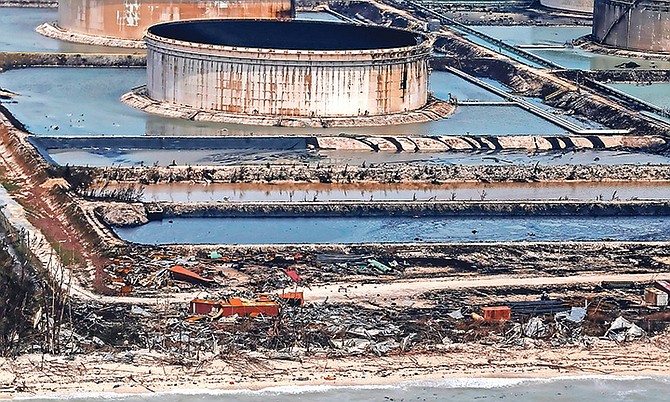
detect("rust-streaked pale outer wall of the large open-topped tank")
[145,22,432,117]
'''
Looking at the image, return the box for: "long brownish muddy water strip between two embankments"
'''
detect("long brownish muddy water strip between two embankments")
[121,181,670,203]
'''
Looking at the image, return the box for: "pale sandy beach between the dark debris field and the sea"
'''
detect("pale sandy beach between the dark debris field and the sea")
[0,340,670,399]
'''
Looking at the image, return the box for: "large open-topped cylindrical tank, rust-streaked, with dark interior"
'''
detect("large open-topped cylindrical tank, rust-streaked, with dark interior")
[145,20,432,117]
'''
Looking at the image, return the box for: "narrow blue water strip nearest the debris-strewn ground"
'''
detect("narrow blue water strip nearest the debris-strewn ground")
[116,215,670,244]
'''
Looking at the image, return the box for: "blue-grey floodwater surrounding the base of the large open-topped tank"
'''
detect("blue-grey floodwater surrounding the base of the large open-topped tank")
[0,68,565,136]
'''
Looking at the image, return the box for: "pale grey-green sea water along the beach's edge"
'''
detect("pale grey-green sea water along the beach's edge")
[17,376,670,402]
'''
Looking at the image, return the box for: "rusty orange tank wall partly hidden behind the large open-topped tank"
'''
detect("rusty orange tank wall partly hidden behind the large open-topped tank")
[58,0,295,40]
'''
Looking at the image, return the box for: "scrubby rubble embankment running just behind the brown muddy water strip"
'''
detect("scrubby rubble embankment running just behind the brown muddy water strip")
[76,163,670,184]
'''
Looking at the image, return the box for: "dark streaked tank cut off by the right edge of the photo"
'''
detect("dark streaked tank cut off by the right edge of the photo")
[593,0,670,52]
